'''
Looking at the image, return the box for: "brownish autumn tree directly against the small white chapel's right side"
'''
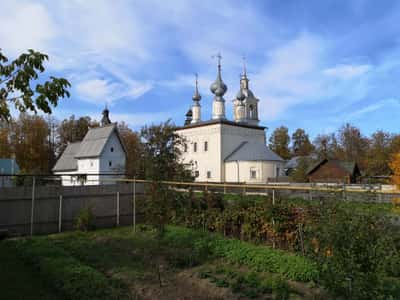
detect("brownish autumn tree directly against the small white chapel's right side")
[118,122,143,177]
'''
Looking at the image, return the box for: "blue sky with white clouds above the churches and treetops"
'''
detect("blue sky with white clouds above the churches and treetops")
[0,0,400,137]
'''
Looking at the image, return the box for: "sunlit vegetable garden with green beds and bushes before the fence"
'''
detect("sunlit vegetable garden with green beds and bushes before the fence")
[0,184,400,299]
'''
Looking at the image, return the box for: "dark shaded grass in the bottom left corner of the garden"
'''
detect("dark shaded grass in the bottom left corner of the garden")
[0,241,63,300]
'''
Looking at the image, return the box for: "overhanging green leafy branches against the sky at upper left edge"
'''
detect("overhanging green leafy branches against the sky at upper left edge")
[0,49,70,121]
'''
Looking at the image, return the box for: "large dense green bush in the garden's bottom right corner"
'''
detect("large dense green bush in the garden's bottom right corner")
[309,206,398,299]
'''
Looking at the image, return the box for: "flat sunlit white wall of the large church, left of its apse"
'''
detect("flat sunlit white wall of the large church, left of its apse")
[176,124,223,182]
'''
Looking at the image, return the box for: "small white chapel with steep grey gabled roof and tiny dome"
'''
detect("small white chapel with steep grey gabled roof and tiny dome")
[53,108,126,186]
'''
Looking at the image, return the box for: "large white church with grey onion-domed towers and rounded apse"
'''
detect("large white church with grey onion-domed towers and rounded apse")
[176,56,285,184]
